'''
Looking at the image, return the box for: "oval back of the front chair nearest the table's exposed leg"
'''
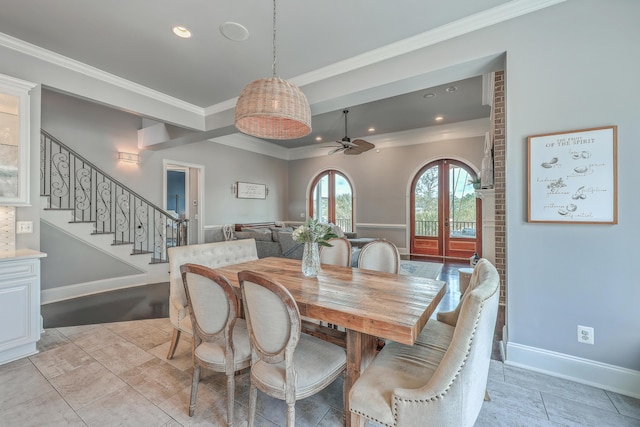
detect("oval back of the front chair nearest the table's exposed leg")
[238,271,301,363]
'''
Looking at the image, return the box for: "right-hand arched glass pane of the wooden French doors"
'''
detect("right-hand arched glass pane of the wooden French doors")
[449,164,476,239]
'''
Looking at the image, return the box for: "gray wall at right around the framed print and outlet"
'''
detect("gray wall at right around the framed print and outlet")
[500,0,640,370]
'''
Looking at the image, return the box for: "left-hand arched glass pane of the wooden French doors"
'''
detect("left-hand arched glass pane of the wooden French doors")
[415,165,440,236]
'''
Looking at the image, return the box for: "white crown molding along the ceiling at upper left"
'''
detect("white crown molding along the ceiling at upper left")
[0,33,204,116]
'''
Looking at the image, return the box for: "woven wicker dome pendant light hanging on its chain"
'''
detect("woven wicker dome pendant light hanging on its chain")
[235,0,311,139]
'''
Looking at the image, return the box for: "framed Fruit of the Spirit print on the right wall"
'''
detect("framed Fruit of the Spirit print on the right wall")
[527,126,618,224]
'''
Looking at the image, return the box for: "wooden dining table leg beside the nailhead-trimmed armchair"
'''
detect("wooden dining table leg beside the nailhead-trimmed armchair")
[344,329,378,427]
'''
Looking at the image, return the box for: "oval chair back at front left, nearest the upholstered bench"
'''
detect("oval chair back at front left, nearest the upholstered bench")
[180,264,239,344]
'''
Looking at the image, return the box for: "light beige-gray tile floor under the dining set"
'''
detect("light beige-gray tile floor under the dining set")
[0,319,640,427]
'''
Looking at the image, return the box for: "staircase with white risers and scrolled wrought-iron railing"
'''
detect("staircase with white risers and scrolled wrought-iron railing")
[40,130,187,294]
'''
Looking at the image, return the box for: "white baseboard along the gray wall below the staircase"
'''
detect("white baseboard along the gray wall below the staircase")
[40,274,148,304]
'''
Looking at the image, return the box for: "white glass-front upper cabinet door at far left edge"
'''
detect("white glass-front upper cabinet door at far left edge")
[0,75,35,206]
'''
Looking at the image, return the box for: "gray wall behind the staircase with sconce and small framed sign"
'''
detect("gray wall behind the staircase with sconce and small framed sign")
[42,90,288,226]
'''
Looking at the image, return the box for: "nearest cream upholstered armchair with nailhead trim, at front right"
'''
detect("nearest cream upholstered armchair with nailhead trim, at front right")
[349,259,500,427]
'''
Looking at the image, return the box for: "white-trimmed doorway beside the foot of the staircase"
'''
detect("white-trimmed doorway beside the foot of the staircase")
[162,159,204,244]
